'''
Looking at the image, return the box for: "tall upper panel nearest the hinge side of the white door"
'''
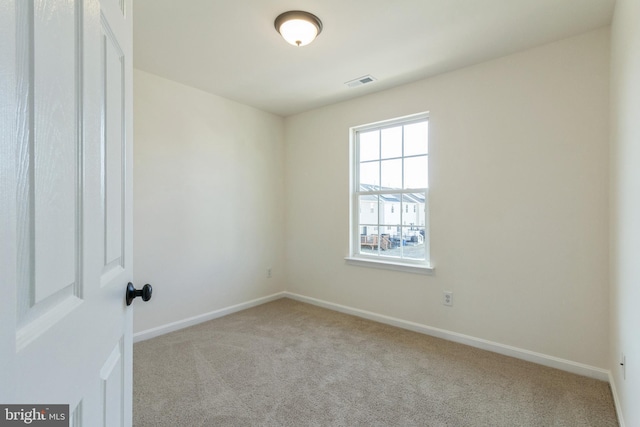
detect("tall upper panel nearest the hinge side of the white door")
[16,0,83,344]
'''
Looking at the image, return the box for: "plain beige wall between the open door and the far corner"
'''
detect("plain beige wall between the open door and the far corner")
[134,70,284,332]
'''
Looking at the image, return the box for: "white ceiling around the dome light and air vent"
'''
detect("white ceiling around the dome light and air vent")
[133,0,615,116]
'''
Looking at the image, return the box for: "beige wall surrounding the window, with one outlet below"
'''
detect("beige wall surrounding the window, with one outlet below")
[285,28,610,368]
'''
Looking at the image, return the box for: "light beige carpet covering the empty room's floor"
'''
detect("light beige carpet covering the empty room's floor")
[134,299,618,427]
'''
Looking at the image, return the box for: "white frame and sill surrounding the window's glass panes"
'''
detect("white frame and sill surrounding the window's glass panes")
[345,112,434,274]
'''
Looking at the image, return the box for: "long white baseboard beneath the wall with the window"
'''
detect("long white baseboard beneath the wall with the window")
[282,292,610,382]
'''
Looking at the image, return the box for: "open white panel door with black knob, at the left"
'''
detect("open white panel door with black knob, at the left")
[0,0,133,427]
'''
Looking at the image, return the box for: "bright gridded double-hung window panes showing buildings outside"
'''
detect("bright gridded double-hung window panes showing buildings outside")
[350,114,429,267]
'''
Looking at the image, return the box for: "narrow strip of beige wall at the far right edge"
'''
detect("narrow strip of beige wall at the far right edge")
[610,0,640,426]
